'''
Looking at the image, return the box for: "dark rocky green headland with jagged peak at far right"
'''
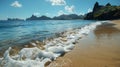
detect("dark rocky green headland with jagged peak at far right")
[84,2,120,20]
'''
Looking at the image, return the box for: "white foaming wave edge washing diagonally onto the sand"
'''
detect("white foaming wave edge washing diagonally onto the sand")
[0,21,106,67]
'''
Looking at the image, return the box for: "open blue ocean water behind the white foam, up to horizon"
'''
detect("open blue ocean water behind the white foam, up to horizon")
[0,20,95,49]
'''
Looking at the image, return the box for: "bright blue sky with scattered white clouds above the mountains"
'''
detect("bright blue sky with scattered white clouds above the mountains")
[0,0,120,20]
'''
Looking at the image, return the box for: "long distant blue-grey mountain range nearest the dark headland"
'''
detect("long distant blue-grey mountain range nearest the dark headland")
[53,14,84,20]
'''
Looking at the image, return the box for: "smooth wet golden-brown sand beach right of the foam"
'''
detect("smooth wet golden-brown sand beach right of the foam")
[48,20,120,67]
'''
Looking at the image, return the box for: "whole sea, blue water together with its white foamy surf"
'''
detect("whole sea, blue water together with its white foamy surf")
[0,20,109,67]
